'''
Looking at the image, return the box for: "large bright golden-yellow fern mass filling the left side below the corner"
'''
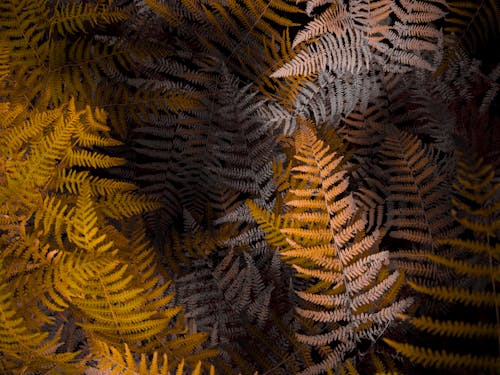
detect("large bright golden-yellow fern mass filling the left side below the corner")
[0,95,213,372]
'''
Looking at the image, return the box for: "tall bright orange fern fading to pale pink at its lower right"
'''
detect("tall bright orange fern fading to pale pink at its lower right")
[248,126,411,374]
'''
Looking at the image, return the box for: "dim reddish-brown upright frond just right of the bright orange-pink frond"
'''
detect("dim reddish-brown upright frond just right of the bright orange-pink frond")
[381,127,457,284]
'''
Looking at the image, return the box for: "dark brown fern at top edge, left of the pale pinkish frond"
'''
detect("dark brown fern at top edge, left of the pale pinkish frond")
[145,0,303,81]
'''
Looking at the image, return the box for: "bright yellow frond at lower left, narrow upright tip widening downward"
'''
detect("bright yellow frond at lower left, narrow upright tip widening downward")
[60,185,188,347]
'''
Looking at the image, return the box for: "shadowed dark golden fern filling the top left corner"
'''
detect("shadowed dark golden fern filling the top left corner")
[0,0,141,110]
